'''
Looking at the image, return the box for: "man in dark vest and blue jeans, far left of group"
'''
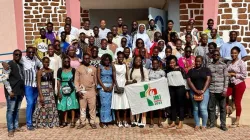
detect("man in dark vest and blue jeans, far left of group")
[0,49,24,137]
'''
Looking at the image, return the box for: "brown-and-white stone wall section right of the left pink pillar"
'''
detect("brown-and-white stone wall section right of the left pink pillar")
[23,0,66,47]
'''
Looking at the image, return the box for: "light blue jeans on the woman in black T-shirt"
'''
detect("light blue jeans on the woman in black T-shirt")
[190,89,209,127]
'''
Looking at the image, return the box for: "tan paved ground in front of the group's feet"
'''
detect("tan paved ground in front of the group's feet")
[0,125,250,140]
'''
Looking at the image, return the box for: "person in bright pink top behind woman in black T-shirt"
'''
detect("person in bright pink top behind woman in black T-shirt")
[178,46,195,73]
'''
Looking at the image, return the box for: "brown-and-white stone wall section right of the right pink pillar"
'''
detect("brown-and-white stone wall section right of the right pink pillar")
[217,0,250,76]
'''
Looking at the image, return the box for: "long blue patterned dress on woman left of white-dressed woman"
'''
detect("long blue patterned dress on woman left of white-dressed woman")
[98,64,114,123]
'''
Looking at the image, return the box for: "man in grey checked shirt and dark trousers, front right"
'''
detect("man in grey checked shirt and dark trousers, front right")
[208,50,228,131]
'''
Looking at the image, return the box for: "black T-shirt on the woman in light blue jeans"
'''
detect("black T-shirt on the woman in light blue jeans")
[187,67,211,90]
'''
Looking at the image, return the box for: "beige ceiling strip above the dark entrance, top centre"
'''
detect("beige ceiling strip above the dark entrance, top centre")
[80,0,168,10]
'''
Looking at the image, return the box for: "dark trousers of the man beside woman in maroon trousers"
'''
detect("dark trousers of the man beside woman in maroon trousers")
[208,93,226,127]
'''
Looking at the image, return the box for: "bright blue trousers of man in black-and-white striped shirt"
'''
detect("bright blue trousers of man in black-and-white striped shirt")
[25,86,38,127]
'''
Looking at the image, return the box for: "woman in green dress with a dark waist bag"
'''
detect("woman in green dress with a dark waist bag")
[57,56,79,128]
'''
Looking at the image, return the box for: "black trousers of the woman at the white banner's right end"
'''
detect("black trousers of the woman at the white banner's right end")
[169,86,186,121]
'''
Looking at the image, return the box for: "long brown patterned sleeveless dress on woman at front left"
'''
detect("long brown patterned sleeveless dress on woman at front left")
[33,72,59,127]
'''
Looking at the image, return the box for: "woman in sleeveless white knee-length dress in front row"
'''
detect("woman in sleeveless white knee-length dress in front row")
[111,51,129,128]
